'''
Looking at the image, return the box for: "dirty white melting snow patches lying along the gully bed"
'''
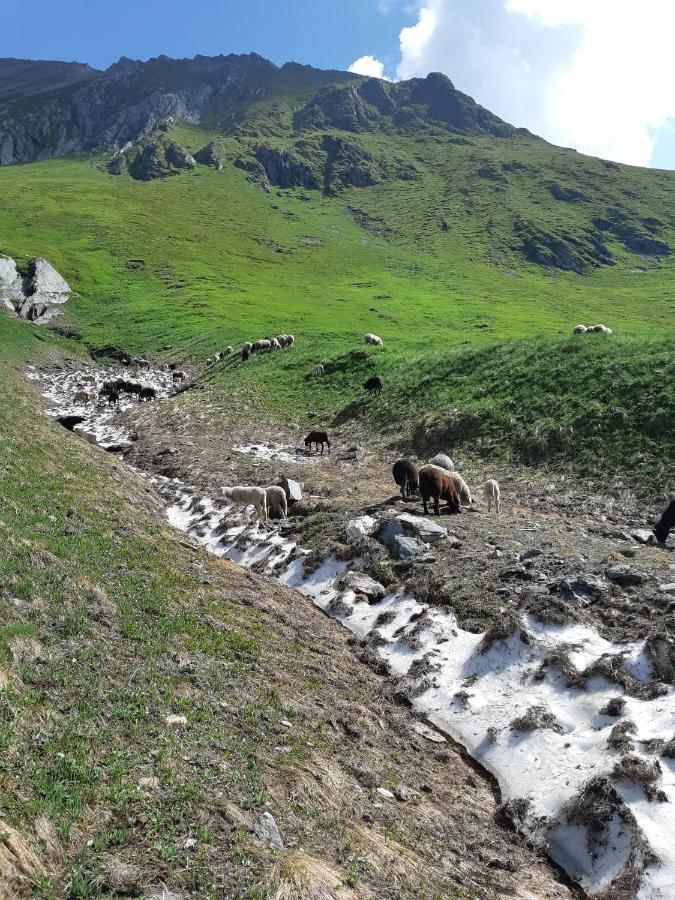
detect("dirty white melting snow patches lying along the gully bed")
[32,364,675,900]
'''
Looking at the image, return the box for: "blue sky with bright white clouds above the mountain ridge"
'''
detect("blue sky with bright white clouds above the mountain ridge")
[0,0,675,169]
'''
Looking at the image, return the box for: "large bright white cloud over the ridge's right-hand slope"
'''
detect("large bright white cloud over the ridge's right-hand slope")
[386,0,675,165]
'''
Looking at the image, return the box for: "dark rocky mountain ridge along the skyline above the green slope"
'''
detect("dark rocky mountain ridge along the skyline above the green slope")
[0,54,515,165]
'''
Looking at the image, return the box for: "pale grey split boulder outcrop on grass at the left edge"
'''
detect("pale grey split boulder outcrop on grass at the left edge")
[0,256,71,325]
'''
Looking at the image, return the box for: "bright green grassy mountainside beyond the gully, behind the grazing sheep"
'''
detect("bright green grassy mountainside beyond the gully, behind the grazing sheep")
[0,117,675,492]
